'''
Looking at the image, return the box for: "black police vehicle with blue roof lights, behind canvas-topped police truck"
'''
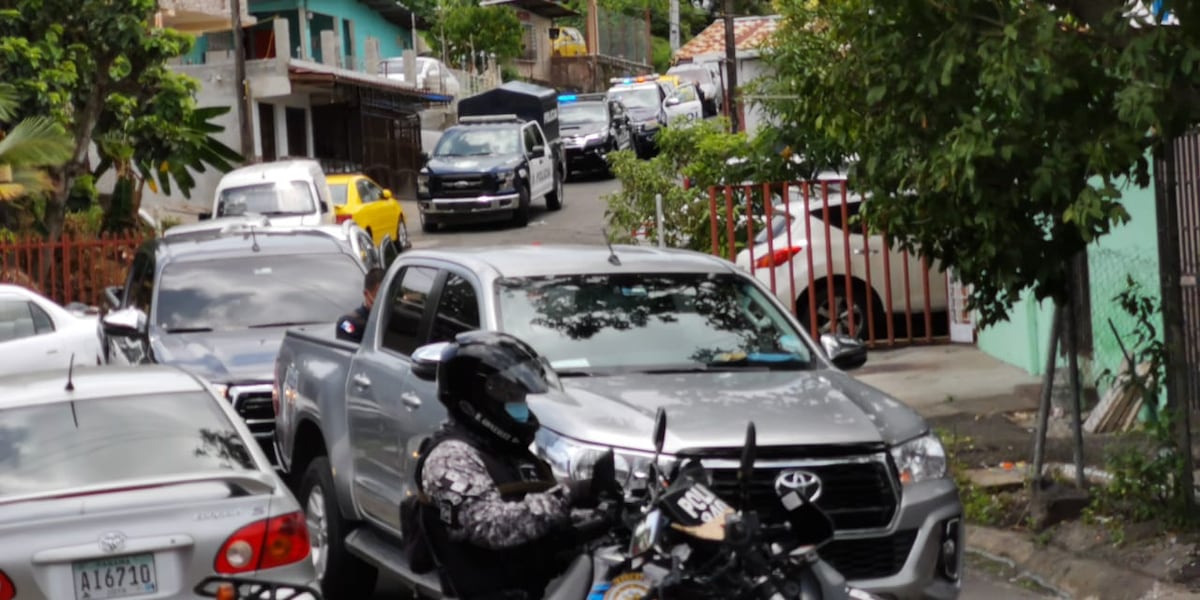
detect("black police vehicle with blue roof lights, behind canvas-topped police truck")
[558,94,634,176]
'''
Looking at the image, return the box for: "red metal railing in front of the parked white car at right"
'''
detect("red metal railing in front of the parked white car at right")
[708,180,949,346]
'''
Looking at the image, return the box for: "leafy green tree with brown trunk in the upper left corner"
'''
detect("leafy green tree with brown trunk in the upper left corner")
[0,0,238,239]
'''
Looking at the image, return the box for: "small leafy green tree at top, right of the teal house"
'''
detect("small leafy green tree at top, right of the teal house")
[426,0,522,65]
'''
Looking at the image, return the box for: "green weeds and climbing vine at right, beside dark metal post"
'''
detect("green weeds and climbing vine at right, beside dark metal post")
[1092,277,1188,524]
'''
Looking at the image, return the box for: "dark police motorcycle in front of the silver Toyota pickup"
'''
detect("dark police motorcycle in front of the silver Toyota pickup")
[545,409,878,600]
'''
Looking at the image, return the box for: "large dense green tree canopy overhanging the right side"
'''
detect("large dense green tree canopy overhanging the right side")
[755,0,1200,326]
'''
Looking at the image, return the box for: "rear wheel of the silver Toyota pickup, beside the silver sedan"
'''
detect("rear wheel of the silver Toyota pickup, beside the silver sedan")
[296,456,378,600]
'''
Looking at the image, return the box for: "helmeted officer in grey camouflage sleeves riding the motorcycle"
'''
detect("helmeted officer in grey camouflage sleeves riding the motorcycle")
[416,331,619,600]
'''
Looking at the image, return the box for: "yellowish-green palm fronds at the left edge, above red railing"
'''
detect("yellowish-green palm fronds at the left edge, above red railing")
[0,84,71,202]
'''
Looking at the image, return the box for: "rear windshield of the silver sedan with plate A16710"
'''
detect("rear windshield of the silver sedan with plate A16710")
[0,382,256,499]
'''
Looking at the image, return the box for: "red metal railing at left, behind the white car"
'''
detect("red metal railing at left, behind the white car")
[0,234,143,306]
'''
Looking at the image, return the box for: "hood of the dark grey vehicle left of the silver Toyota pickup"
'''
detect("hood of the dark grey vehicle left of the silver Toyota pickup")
[152,324,298,384]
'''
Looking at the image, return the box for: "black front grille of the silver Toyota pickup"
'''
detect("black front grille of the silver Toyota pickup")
[702,452,916,580]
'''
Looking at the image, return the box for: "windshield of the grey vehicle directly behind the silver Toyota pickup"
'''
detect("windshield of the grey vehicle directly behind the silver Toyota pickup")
[159,253,362,334]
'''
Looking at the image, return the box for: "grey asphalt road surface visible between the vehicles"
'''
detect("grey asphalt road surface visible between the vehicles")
[374,178,1044,600]
